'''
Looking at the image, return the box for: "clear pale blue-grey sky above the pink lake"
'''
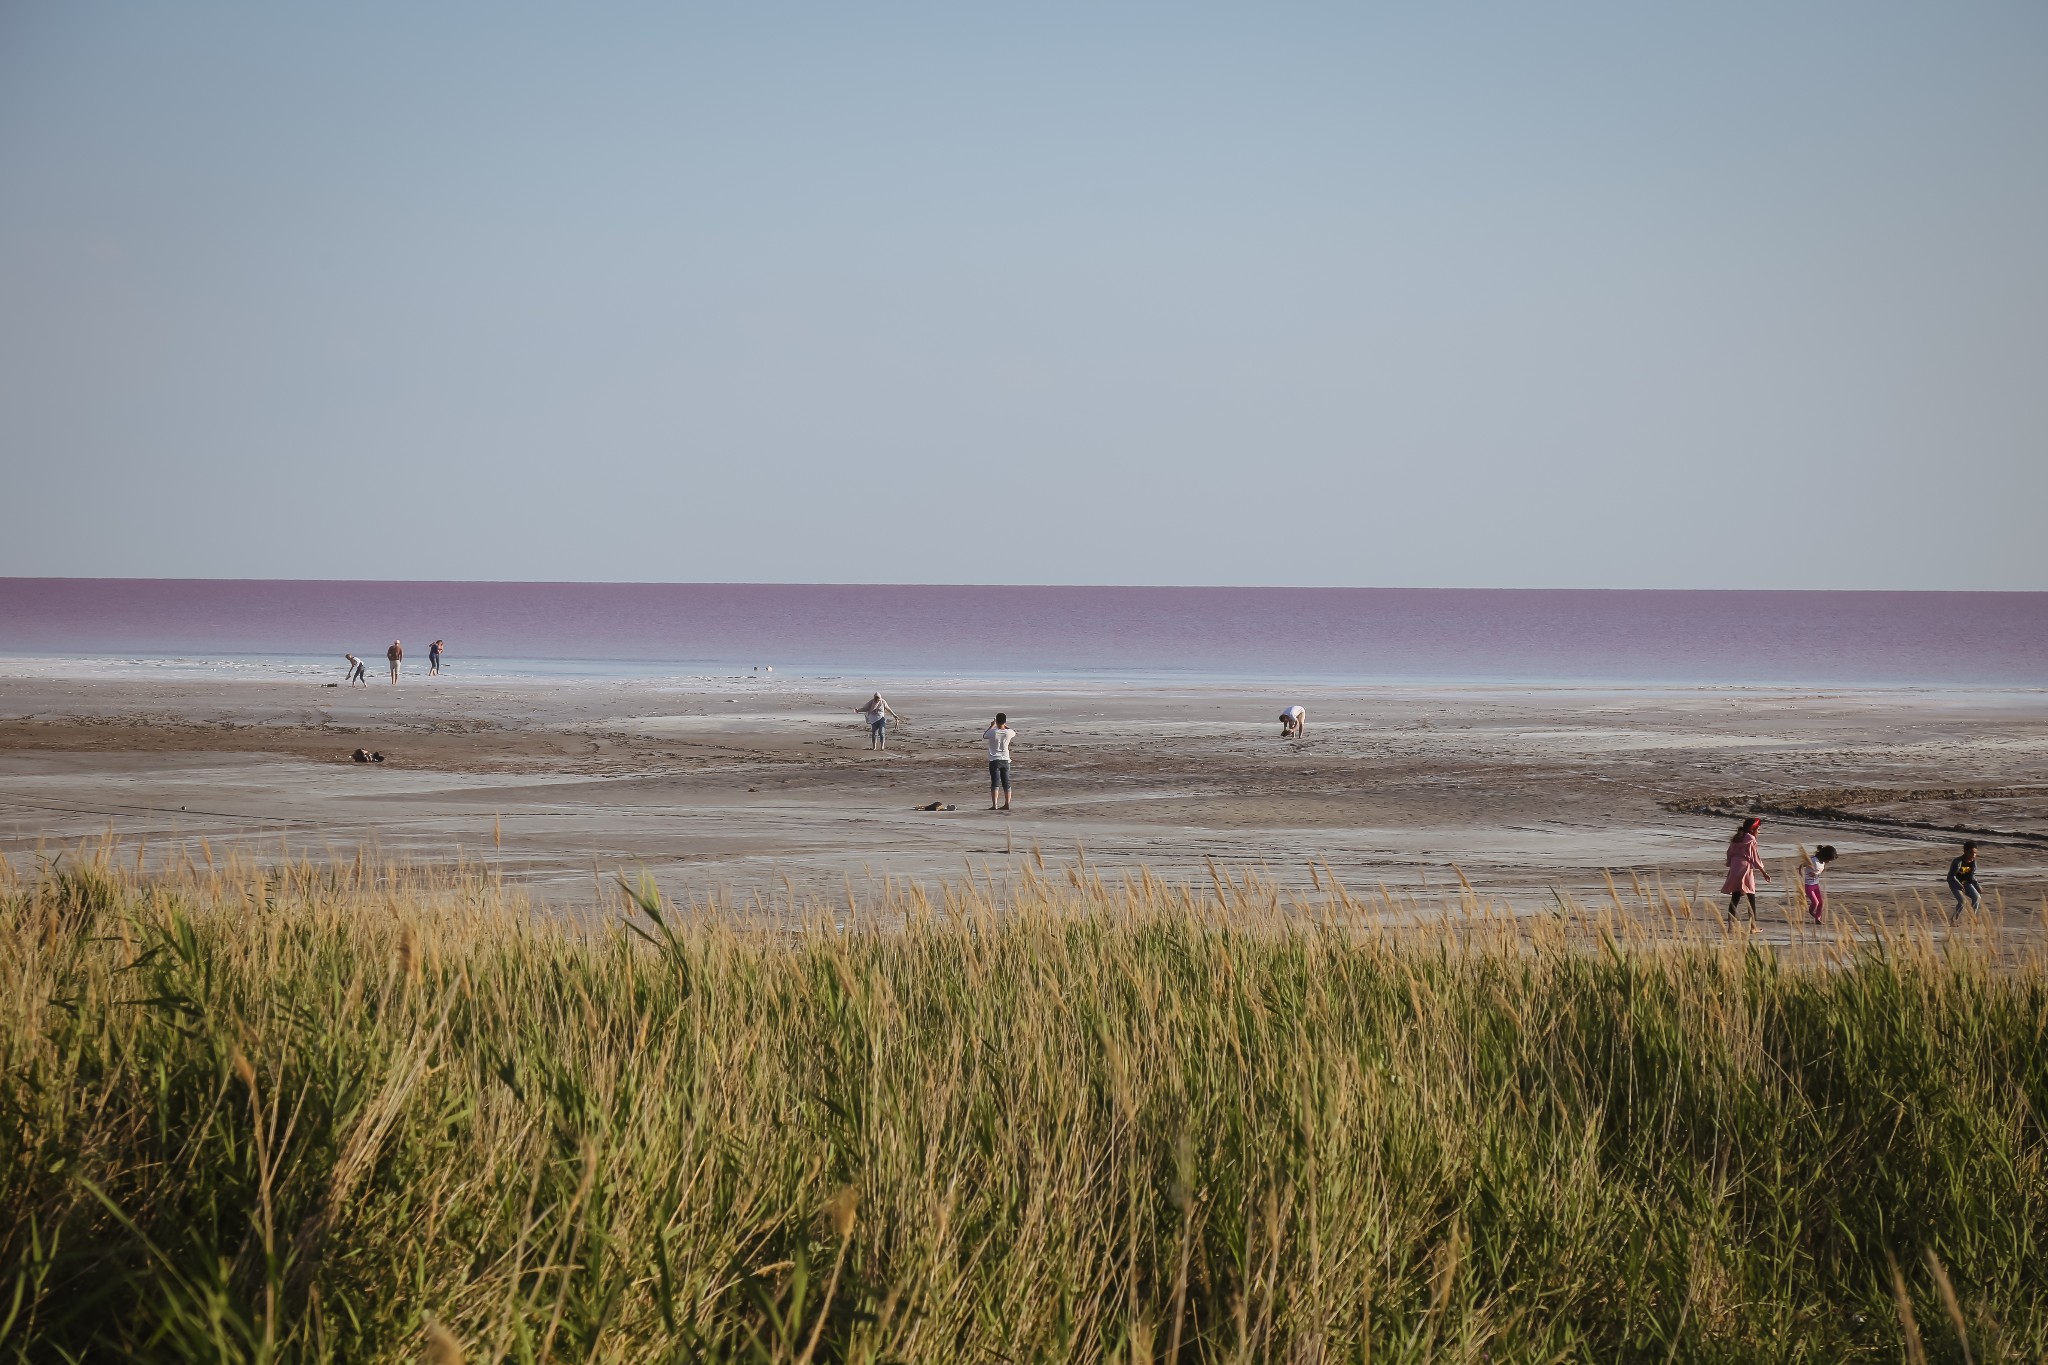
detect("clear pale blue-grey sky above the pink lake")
[0,0,2048,589]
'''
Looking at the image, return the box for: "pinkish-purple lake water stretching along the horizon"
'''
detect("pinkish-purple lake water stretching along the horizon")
[0,579,2048,688]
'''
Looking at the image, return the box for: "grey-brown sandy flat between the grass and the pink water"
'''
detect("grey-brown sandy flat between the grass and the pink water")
[0,665,2048,915]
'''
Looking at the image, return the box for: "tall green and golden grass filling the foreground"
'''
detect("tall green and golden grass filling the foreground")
[0,849,2048,1363]
